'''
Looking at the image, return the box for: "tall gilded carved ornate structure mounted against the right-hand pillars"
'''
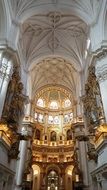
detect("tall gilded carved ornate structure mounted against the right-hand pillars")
[83,66,104,133]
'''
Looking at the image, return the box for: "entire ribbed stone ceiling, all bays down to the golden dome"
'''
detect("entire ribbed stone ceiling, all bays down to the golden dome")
[9,0,100,96]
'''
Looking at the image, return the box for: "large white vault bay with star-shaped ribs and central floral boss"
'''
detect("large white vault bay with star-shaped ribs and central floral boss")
[20,12,88,70]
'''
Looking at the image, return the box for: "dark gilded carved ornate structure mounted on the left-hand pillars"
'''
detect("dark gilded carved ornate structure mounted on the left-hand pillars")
[2,70,27,125]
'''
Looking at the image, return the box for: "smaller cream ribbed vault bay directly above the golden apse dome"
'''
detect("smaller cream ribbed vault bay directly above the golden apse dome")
[30,57,78,98]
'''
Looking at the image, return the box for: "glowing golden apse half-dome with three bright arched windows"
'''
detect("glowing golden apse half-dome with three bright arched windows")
[35,87,72,111]
